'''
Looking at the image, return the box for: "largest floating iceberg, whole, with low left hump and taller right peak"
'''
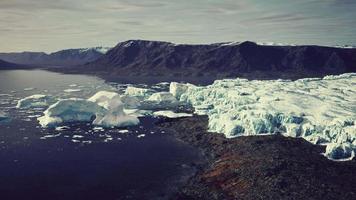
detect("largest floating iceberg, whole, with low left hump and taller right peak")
[37,91,139,127]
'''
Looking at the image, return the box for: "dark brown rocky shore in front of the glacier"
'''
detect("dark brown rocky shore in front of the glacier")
[158,116,356,200]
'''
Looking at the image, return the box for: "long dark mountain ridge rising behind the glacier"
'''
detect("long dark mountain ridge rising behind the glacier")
[80,40,356,79]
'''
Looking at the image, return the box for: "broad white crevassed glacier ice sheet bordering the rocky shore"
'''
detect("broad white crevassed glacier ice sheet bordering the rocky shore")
[170,73,356,160]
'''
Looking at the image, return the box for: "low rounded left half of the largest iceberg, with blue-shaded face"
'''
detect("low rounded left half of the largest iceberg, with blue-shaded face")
[37,99,106,127]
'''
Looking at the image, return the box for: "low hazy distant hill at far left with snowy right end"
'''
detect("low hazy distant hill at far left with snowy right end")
[0,47,109,67]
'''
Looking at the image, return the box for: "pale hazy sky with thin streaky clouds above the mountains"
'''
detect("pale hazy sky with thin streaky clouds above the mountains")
[0,0,356,52]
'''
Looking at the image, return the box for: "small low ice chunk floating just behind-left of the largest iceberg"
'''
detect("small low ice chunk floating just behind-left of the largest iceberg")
[16,94,54,108]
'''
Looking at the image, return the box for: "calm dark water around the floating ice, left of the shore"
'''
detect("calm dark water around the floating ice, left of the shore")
[0,70,203,200]
